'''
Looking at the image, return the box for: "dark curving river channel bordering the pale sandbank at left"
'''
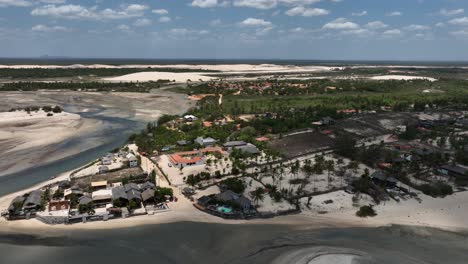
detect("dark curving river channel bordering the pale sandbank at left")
[0,105,145,196]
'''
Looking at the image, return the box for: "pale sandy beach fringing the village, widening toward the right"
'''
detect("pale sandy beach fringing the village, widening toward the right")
[0,167,468,233]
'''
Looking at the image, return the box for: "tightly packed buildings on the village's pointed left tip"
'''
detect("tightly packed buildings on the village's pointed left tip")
[8,177,168,224]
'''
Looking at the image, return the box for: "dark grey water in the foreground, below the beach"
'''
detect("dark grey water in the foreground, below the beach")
[0,223,468,264]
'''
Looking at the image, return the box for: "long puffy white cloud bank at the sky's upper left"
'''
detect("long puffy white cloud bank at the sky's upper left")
[31,4,148,20]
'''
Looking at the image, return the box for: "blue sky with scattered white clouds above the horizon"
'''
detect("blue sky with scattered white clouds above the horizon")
[0,0,468,60]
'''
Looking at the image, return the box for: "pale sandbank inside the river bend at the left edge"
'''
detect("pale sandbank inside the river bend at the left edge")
[0,111,96,176]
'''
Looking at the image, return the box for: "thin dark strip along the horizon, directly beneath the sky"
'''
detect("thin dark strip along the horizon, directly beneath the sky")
[0,57,468,66]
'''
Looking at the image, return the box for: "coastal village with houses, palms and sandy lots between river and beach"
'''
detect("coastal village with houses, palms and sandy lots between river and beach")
[2,77,468,224]
